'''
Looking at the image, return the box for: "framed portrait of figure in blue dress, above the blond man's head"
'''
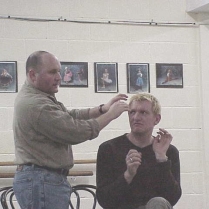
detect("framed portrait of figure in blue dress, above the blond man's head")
[127,63,150,94]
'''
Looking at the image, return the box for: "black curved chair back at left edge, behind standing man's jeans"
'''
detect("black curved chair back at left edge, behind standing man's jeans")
[0,186,15,209]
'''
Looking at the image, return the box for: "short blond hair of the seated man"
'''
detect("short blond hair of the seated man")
[129,93,161,114]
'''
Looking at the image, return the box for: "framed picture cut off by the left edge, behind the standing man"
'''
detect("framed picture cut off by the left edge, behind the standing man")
[0,61,17,93]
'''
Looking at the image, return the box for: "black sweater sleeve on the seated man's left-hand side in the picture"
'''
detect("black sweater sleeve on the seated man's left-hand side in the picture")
[96,145,129,209]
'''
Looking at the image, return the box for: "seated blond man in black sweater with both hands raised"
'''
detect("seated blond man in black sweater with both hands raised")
[97,93,181,209]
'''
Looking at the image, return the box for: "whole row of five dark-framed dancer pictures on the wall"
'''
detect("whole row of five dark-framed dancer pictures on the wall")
[0,61,183,93]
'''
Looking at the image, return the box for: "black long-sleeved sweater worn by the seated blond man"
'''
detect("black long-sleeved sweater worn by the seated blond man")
[97,134,181,209]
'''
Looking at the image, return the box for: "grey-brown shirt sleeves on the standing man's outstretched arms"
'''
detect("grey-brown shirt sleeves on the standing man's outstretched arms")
[33,102,100,145]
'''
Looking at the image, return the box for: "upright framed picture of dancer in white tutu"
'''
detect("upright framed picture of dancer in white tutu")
[94,63,118,93]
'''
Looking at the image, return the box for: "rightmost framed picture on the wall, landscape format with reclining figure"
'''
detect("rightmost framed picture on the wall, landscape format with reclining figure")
[156,63,183,88]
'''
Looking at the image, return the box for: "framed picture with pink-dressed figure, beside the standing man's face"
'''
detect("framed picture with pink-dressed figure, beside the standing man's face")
[60,62,88,87]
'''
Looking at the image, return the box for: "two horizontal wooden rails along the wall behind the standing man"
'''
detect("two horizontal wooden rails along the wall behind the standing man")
[0,159,96,178]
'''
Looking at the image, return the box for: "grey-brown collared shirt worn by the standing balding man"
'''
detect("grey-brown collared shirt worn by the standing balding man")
[13,81,99,169]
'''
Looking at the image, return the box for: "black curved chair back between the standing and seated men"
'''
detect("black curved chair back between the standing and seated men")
[69,184,97,209]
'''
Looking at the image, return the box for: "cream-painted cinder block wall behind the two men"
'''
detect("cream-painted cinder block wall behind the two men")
[0,0,207,209]
